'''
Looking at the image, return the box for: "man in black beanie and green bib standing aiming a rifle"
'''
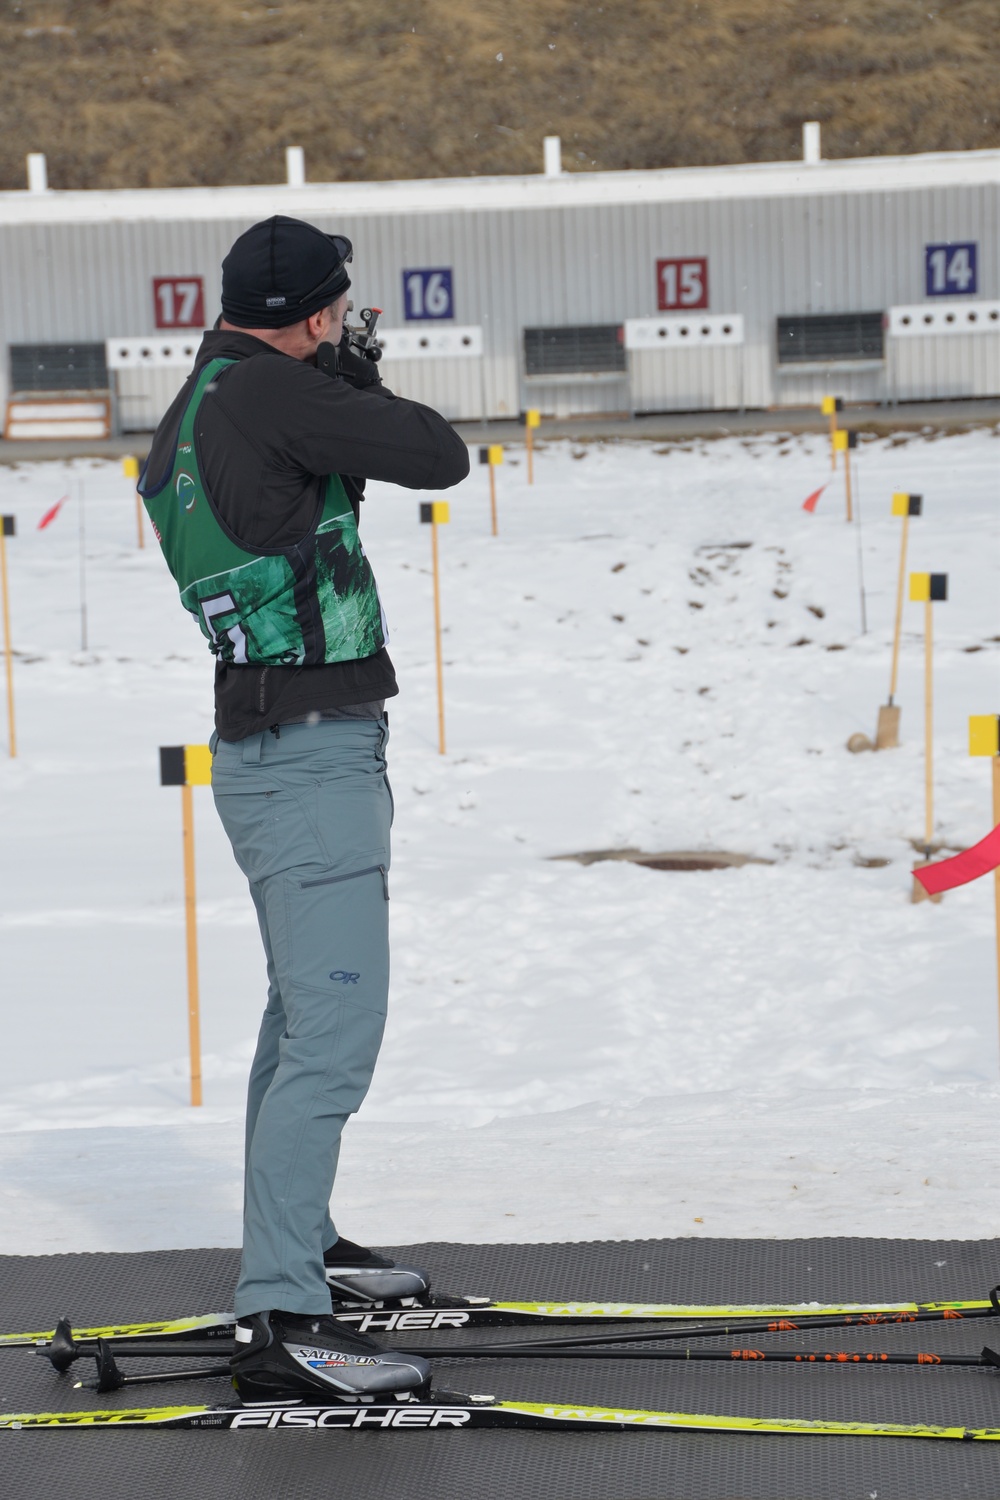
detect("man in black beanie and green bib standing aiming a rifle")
[139,215,469,1400]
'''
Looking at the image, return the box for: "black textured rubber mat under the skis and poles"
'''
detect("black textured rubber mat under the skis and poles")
[0,1239,1000,1500]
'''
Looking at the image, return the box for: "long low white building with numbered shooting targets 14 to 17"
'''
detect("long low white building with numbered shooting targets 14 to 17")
[0,128,1000,431]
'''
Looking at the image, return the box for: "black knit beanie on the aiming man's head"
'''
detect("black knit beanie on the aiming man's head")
[222,213,352,329]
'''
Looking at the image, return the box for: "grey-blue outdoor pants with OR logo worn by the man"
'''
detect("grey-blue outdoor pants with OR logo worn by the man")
[211,720,393,1317]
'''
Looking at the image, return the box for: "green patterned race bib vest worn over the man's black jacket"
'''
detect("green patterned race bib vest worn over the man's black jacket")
[139,360,387,666]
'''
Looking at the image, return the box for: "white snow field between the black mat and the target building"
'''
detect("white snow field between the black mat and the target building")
[0,429,1000,1254]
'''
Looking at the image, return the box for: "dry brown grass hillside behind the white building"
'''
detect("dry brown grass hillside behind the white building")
[0,0,1000,189]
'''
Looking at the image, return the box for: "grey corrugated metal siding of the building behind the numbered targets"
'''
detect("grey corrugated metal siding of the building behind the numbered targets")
[0,172,1000,420]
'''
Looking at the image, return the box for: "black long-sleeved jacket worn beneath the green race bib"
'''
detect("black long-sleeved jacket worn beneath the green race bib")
[147,330,469,740]
